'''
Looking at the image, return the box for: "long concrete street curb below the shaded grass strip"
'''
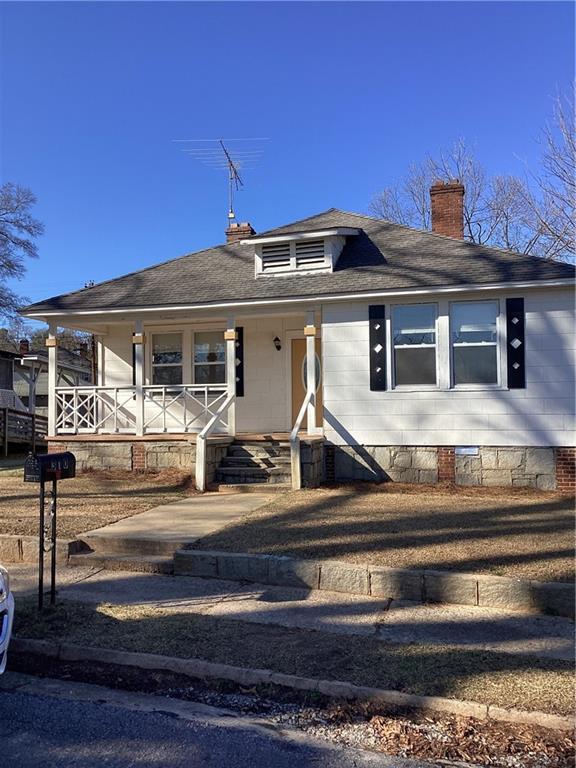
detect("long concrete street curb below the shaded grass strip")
[11,637,573,731]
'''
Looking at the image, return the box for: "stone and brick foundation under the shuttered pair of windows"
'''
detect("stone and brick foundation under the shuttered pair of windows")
[326,445,576,492]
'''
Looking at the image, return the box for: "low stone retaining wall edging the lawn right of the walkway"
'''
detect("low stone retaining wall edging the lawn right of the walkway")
[174,549,575,618]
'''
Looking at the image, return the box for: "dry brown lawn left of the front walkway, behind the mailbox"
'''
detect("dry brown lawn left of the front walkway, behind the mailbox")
[0,470,193,539]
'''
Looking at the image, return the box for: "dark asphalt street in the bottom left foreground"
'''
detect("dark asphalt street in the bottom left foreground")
[0,673,420,768]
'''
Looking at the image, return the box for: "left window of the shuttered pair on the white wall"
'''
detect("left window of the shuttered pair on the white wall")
[392,304,438,386]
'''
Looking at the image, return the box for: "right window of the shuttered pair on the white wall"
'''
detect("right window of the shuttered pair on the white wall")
[450,301,499,385]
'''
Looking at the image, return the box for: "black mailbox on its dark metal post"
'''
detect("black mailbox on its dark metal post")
[24,451,76,611]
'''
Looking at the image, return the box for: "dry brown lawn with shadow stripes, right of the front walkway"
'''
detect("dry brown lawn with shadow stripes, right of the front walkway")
[191,483,574,581]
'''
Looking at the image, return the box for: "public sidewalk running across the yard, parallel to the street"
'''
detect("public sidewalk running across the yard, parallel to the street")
[10,566,574,660]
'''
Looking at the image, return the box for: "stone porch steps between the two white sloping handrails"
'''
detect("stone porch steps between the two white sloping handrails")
[215,439,292,486]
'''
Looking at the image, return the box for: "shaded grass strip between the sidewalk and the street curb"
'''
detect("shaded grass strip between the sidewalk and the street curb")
[15,600,574,715]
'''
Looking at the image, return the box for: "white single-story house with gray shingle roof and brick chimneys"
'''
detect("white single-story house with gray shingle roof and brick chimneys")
[23,182,575,490]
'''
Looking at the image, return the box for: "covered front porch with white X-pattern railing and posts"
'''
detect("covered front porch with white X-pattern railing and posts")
[47,310,322,490]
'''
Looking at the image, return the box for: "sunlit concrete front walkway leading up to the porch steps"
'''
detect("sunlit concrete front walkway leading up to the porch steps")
[78,493,270,542]
